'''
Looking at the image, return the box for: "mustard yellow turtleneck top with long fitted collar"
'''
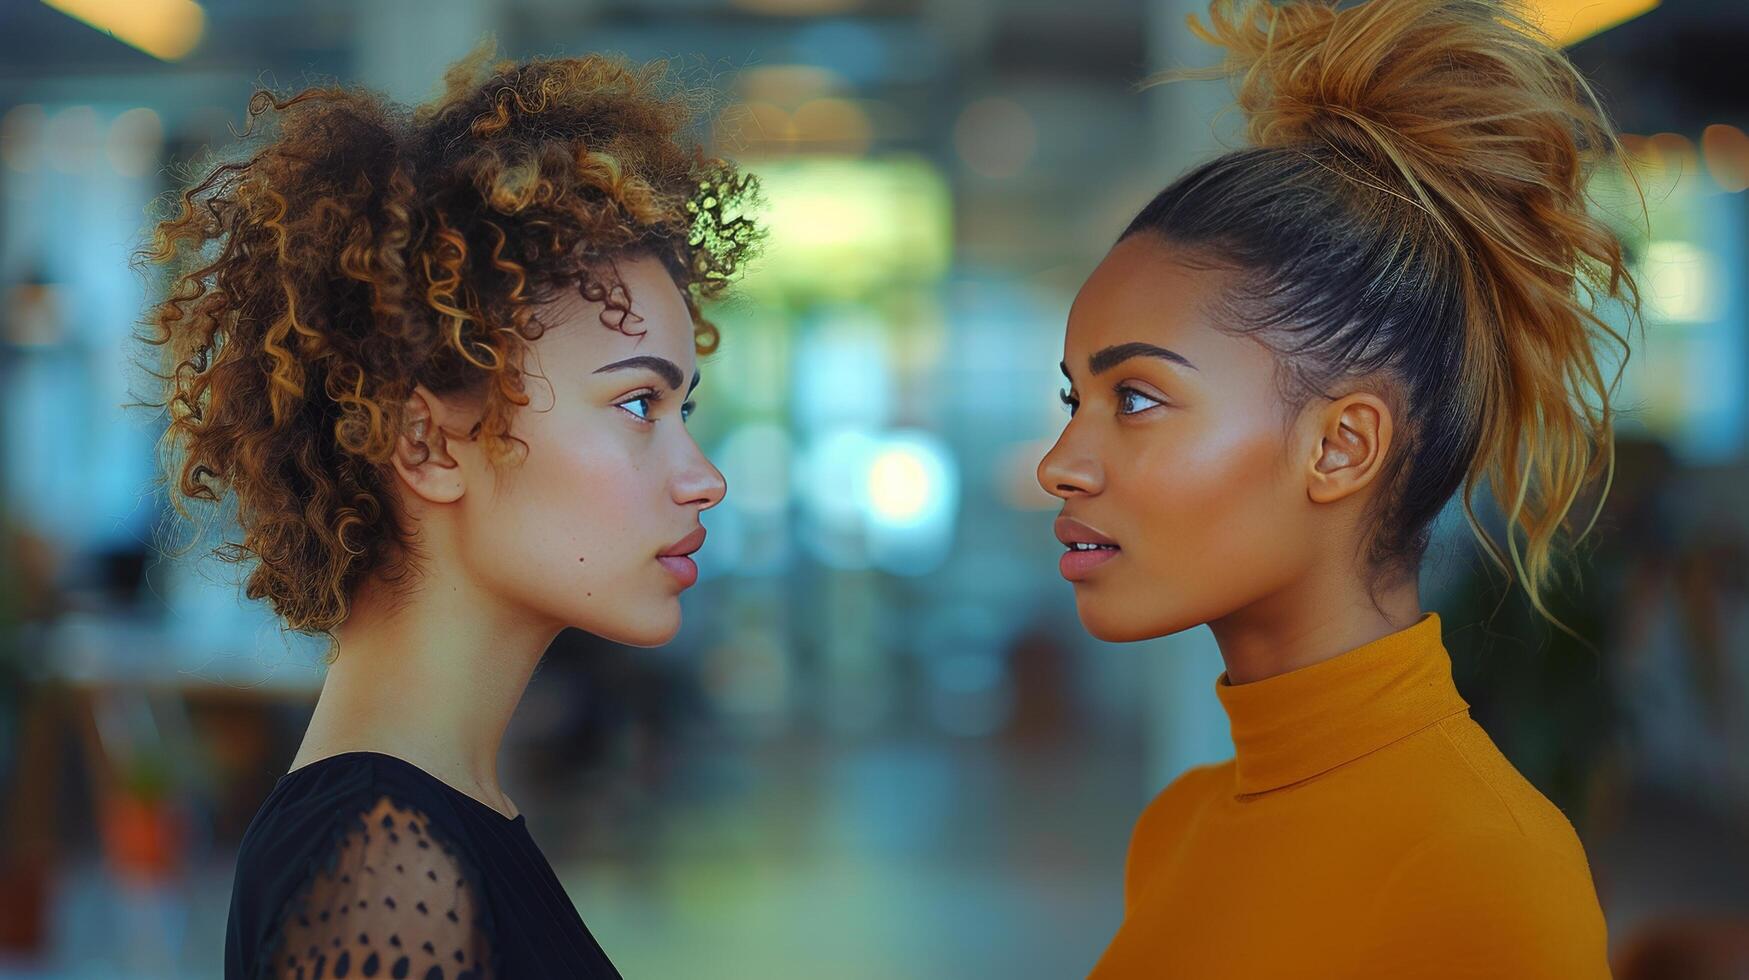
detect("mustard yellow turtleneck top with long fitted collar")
[1090,613,1609,980]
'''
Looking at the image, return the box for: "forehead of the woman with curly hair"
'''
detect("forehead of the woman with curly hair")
[539,257,696,373]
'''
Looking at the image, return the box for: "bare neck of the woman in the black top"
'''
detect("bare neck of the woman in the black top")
[292,562,558,816]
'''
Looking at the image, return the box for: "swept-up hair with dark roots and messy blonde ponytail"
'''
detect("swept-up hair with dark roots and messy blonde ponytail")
[1126,0,1639,616]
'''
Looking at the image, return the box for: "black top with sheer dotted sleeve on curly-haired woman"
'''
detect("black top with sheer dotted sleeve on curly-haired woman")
[224,751,619,980]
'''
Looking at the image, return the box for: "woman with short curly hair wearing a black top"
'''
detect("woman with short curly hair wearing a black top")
[145,45,756,980]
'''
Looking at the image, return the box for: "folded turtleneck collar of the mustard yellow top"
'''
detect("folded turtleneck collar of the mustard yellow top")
[1214,613,1469,796]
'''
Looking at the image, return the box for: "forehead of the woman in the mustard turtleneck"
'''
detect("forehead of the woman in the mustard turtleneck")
[1065,235,1233,358]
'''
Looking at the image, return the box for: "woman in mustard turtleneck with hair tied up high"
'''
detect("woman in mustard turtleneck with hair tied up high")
[1039,0,1639,980]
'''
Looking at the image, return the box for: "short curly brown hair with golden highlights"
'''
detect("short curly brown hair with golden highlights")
[140,49,759,637]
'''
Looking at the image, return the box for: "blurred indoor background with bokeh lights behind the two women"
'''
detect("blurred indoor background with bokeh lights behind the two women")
[0,0,1749,978]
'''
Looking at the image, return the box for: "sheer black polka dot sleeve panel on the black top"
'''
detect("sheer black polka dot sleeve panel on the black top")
[264,796,491,980]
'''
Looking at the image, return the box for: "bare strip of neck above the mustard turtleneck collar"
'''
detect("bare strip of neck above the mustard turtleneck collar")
[1209,574,1422,684]
